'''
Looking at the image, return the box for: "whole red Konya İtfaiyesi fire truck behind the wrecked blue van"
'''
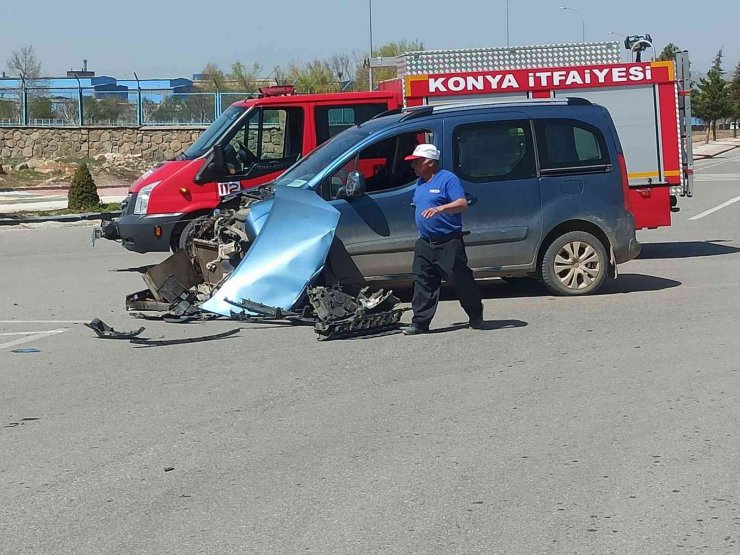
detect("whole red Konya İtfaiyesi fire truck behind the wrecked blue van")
[98,42,693,252]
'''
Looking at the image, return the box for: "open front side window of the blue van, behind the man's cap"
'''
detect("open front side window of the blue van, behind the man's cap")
[322,129,434,199]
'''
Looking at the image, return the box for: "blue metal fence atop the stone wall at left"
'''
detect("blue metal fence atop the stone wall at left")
[0,83,256,127]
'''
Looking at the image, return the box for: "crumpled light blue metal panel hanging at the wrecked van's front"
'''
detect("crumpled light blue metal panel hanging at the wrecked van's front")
[200,187,339,316]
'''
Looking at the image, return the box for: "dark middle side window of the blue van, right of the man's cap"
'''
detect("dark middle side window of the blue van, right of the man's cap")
[453,120,537,183]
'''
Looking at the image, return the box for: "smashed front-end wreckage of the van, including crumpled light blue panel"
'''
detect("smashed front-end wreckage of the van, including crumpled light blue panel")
[121,187,408,340]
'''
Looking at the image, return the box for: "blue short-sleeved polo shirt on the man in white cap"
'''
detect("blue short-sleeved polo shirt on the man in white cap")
[414,170,465,239]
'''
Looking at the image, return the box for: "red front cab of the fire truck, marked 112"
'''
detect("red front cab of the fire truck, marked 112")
[105,87,401,253]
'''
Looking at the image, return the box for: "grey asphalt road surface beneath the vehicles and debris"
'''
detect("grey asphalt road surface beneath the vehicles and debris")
[0,150,740,554]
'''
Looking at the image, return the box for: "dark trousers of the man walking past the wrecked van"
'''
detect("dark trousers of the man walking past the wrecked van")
[411,237,483,329]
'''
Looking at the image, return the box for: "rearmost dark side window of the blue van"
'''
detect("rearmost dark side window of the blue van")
[535,119,609,170]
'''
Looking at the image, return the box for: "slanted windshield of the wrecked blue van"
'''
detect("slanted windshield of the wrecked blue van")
[275,127,370,189]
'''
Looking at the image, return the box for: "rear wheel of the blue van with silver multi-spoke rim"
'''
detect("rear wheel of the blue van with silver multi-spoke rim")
[541,231,609,296]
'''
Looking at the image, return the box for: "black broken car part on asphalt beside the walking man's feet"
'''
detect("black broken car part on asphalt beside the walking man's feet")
[308,285,408,340]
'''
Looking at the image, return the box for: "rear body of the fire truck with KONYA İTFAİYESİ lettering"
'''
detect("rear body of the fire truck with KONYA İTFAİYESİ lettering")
[380,42,694,229]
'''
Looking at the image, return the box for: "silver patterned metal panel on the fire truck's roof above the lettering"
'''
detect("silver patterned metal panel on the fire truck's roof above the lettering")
[398,42,621,77]
